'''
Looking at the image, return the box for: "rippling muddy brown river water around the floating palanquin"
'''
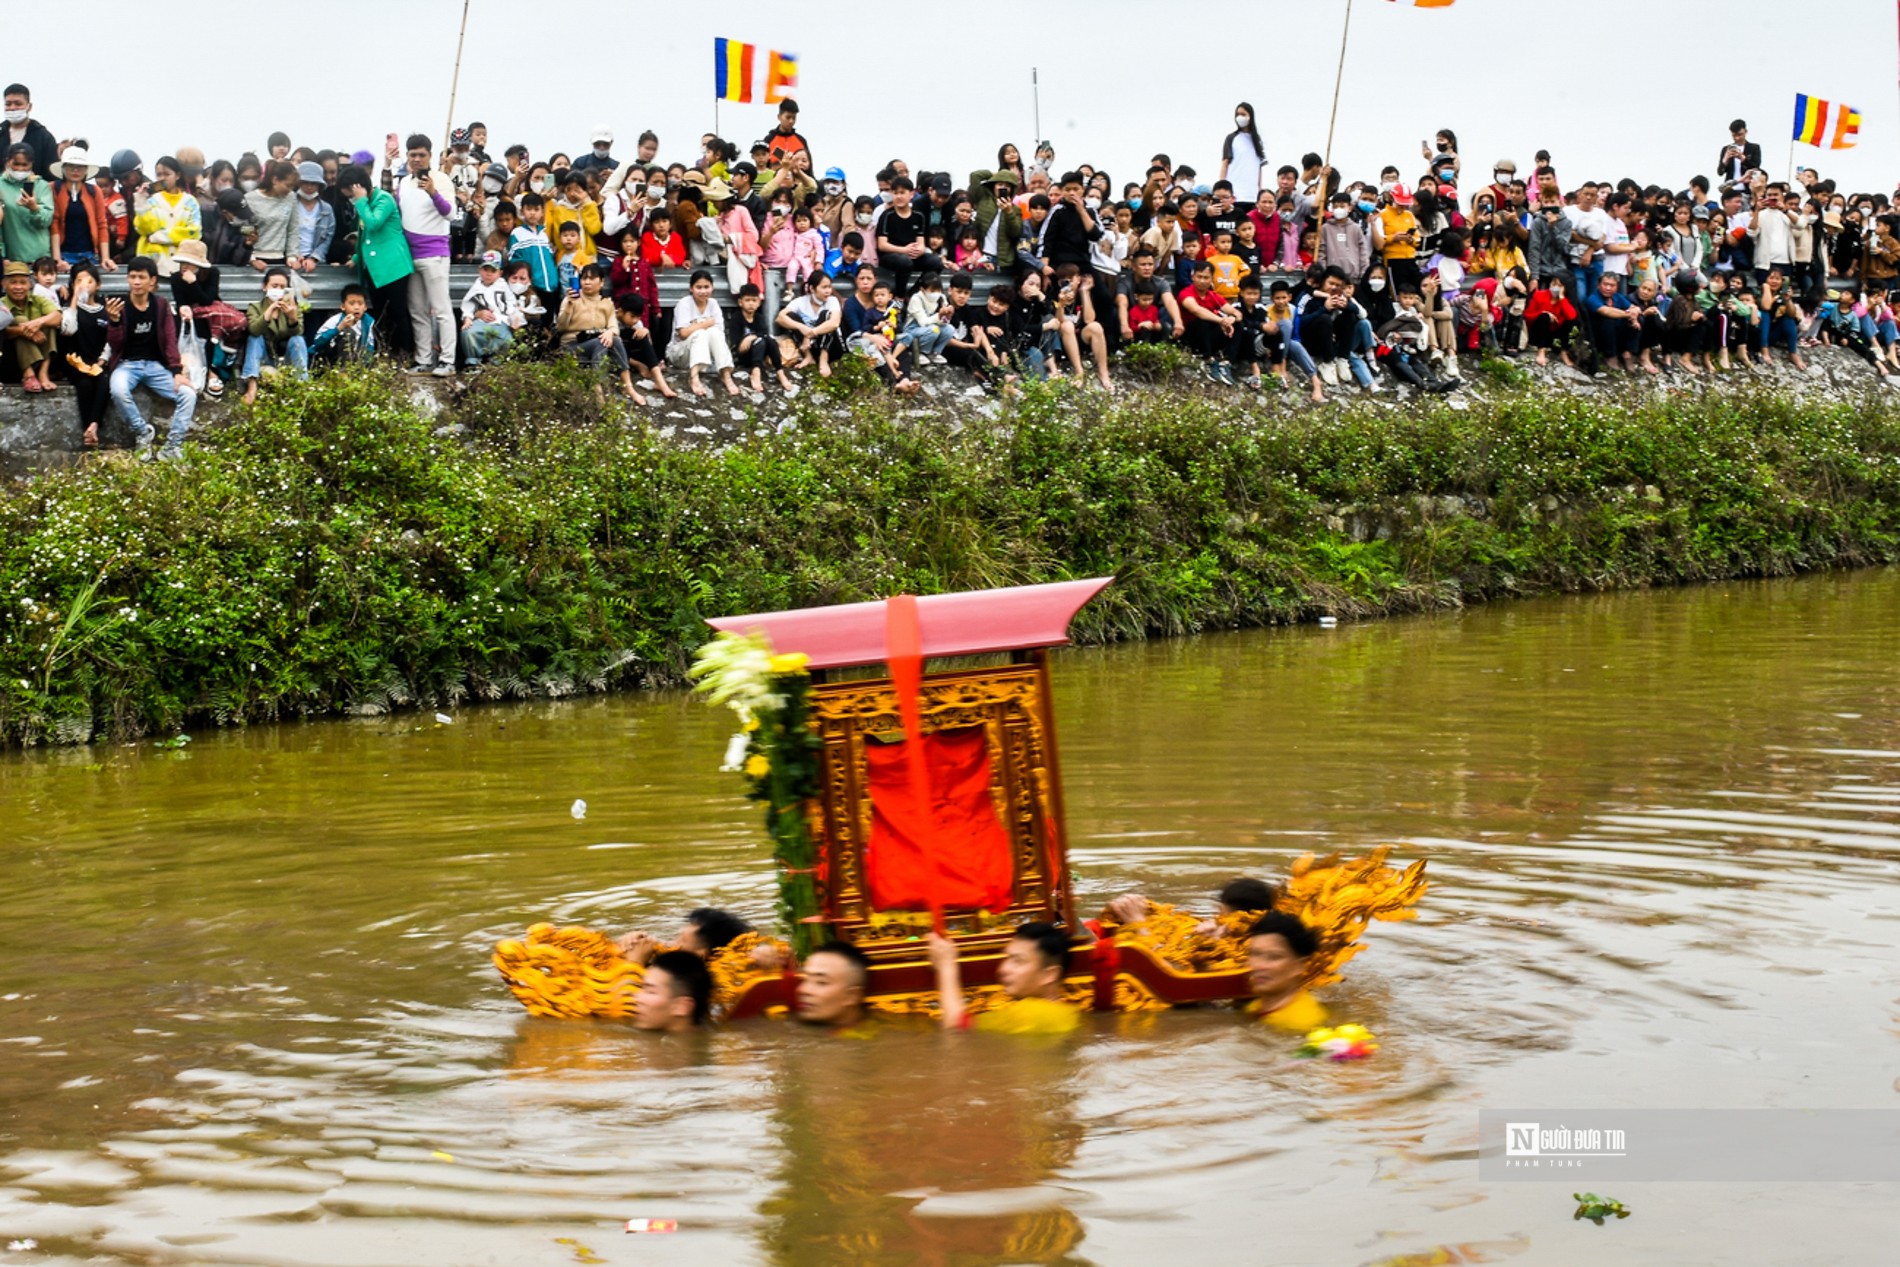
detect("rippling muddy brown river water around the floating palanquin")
[0,570,1900,1267]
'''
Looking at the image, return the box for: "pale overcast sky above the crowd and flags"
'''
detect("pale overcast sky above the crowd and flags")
[26,0,1900,190]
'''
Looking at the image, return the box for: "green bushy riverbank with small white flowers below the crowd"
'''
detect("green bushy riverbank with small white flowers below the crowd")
[0,365,1900,743]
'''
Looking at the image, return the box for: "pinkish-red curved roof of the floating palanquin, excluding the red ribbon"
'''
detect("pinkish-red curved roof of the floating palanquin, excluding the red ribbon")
[707,576,1115,669]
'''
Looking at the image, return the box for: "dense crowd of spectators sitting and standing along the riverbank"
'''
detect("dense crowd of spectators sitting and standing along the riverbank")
[0,84,1900,456]
